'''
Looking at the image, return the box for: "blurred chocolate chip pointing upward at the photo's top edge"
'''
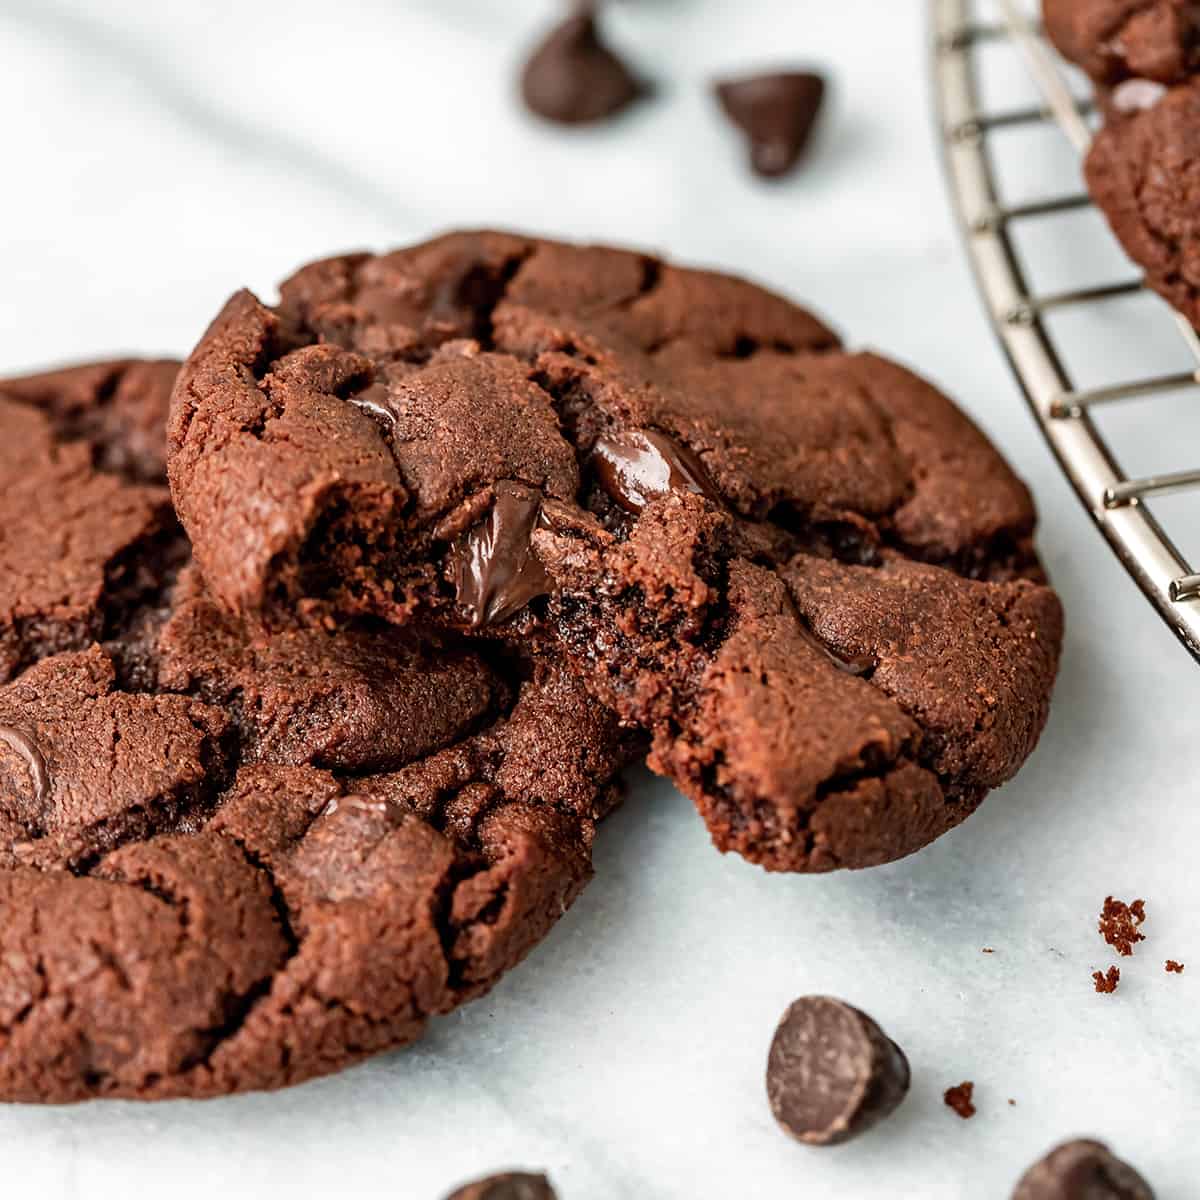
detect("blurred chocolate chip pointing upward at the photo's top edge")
[521,5,646,125]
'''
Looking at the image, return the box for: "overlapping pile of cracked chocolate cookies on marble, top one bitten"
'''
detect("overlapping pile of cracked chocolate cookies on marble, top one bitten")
[0,233,1061,1100]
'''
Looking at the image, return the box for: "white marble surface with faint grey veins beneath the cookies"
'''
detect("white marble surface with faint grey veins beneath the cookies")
[0,0,1200,1200]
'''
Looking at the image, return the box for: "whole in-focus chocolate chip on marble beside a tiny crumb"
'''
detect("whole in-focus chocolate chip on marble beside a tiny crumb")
[767,996,910,1146]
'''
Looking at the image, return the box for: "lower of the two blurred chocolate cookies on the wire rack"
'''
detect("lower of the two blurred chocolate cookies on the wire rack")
[1086,78,1200,325]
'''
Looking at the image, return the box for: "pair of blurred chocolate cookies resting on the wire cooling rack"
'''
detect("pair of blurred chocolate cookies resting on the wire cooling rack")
[1043,0,1200,326]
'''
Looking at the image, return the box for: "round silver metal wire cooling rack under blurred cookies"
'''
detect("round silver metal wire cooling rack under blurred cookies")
[931,0,1200,660]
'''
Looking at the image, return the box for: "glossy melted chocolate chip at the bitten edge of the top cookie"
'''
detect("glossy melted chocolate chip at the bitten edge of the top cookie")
[452,481,553,629]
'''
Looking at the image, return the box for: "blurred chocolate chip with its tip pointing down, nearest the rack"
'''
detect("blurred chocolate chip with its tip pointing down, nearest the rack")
[715,71,824,178]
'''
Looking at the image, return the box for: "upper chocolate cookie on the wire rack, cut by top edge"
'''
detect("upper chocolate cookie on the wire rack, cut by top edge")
[1042,0,1200,84]
